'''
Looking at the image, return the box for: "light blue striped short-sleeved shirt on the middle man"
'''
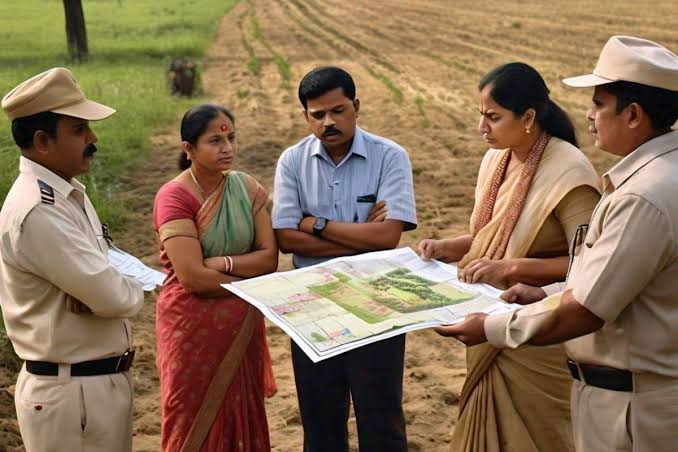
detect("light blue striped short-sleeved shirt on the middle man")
[272,127,417,268]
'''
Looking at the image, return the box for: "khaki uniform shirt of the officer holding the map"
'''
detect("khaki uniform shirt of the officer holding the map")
[485,131,678,378]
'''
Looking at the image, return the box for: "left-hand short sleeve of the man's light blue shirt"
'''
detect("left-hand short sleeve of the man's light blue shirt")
[271,150,304,229]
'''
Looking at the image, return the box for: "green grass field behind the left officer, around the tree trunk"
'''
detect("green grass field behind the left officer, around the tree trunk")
[0,0,237,332]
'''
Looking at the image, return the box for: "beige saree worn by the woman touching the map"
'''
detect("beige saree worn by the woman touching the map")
[452,137,600,452]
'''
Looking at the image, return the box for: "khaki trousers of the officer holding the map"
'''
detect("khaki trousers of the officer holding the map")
[571,374,678,452]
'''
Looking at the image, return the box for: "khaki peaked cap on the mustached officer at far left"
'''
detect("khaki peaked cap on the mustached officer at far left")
[2,67,115,121]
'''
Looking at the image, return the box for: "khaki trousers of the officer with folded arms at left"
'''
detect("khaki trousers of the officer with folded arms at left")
[14,365,133,452]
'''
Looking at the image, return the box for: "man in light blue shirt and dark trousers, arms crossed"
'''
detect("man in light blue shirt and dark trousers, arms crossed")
[273,67,417,452]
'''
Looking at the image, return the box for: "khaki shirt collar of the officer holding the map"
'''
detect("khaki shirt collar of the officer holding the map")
[603,130,678,190]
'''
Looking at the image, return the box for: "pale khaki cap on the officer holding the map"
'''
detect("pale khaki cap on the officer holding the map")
[563,36,678,91]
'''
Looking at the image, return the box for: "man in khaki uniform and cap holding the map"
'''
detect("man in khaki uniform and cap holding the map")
[439,36,678,452]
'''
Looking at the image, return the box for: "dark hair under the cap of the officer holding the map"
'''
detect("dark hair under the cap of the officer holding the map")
[600,81,678,130]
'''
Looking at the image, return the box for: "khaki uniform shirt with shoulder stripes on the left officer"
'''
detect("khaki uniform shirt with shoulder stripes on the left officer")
[0,157,143,364]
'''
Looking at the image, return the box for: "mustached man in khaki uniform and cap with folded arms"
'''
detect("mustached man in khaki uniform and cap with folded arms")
[0,68,143,452]
